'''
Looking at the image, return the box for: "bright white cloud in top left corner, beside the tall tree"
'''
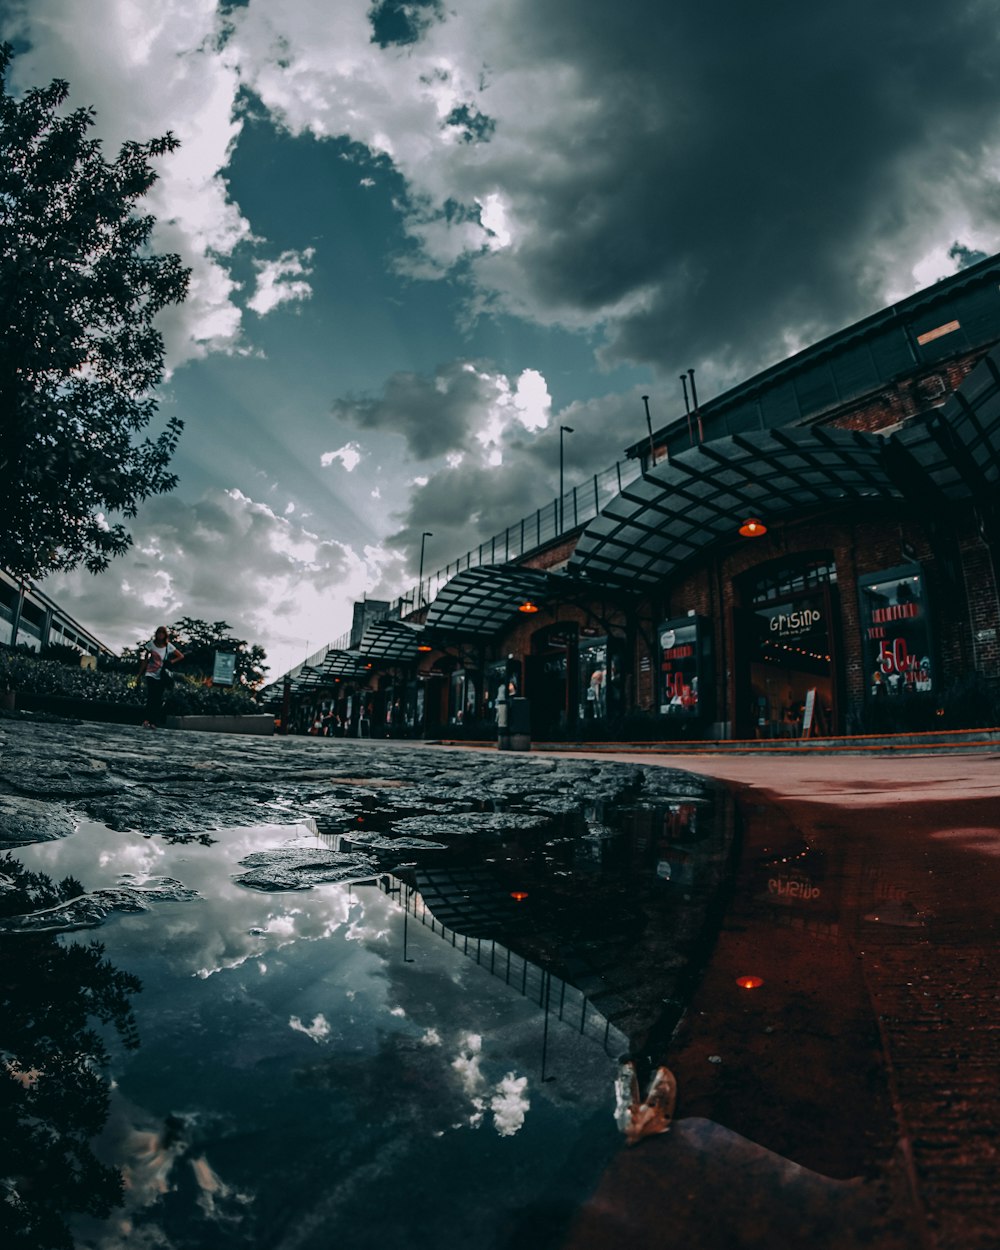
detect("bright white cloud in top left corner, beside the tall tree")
[10,0,253,368]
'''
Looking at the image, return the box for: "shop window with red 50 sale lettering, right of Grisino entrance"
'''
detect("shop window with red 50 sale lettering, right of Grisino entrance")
[858,565,934,699]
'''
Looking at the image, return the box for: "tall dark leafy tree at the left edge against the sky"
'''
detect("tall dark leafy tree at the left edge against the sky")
[0,44,190,578]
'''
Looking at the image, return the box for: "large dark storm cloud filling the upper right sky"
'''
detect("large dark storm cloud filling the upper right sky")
[480,0,1000,382]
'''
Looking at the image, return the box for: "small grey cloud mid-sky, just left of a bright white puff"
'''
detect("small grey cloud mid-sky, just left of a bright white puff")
[333,361,505,460]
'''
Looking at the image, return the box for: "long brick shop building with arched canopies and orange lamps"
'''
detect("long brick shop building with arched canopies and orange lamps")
[275,258,1000,740]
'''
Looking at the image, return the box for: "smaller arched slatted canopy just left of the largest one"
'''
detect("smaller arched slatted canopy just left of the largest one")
[426,564,571,638]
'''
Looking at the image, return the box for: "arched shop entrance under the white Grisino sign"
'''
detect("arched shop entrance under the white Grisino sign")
[734,559,839,738]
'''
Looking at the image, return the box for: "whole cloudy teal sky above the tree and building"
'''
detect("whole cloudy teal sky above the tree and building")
[0,0,1000,678]
